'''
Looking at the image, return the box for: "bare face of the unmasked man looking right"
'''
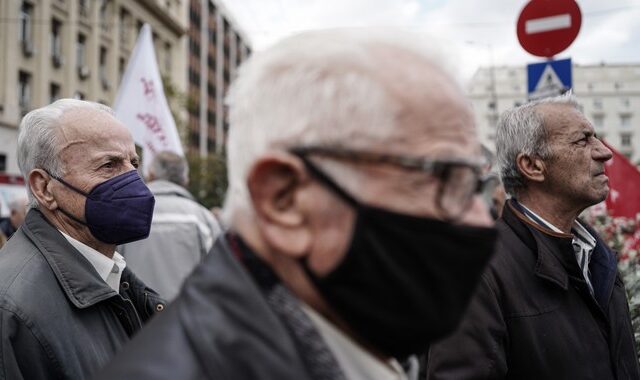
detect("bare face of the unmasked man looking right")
[540,104,611,211]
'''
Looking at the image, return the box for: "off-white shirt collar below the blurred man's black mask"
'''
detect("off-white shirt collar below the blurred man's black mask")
[302,304,407,380]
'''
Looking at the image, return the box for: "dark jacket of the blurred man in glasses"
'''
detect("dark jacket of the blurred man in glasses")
[97,236,320,380]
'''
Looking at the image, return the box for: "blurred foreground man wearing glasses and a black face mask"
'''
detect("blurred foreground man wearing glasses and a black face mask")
[96,30,496,380]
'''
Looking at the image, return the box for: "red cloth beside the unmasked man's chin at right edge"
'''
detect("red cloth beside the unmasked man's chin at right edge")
[604,143,640,219]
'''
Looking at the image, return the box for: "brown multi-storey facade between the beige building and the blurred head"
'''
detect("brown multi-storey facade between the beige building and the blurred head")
[187,0,251,156]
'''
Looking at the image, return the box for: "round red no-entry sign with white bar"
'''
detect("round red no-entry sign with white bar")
[517,0,582,57]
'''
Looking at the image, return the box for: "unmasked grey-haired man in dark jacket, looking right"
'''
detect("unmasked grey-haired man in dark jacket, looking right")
[428,95,640,380]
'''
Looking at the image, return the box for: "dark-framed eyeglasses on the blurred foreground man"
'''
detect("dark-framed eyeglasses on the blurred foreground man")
[289,146,495,221]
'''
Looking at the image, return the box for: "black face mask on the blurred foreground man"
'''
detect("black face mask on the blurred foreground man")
[301,157,497,358]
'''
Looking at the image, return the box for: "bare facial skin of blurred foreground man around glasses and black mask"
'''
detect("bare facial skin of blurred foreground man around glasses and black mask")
[308,51,493,276]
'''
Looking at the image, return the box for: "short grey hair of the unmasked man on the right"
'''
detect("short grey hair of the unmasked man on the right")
[496,93,580,196]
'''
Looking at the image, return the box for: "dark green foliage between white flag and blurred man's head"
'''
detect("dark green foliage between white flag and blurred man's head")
[187,152,227,208]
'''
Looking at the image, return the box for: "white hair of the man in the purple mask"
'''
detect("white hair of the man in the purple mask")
[17,99,114,208]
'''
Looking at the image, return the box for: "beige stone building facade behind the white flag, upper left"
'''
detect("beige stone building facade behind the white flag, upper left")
[0,0,189,174]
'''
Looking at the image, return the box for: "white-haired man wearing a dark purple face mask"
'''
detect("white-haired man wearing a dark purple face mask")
[0,99,164,380]
